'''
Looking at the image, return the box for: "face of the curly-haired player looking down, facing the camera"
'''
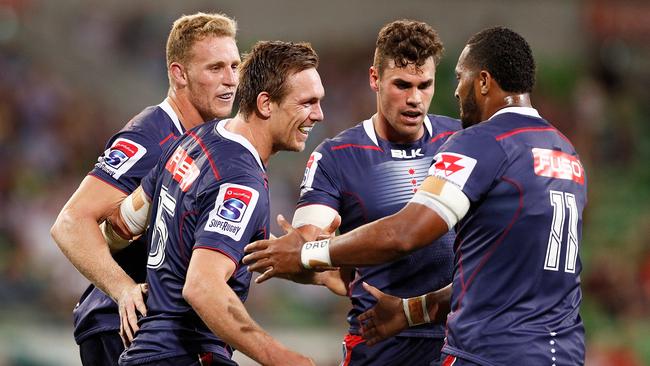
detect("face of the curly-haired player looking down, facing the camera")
[370,57,436,142]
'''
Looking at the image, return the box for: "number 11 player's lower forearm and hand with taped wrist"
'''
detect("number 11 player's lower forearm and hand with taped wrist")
[358,282,451,346]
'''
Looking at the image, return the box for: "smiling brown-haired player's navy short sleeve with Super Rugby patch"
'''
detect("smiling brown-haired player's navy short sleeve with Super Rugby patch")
[194,175,269,264]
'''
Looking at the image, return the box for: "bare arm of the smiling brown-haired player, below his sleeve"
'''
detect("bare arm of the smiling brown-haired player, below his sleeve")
[183,248,313,365]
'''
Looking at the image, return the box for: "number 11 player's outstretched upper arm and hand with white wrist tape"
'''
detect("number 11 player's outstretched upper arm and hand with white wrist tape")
[244,176,469,282]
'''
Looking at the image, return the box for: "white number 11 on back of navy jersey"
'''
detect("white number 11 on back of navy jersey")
[544,191,578,273]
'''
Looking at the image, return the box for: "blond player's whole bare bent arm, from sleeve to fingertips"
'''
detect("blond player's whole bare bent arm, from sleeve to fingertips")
[51,176,151,346]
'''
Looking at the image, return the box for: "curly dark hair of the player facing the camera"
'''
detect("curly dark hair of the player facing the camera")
[374,19,444,76]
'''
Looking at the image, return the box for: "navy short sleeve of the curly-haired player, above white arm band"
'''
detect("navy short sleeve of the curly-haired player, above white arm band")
[297,142,341,211]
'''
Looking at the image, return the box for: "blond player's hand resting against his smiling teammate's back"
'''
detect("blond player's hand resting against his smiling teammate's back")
[117,283,149,347]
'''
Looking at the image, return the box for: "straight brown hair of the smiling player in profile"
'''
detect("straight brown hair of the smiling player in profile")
[237,41,318,117]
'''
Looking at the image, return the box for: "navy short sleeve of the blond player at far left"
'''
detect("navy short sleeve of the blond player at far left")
[89,130,162,193]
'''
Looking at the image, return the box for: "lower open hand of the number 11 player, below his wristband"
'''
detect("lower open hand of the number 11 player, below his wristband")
[358,282,408,346]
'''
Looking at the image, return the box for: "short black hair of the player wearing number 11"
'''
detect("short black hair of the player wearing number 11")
[466,27,535,93]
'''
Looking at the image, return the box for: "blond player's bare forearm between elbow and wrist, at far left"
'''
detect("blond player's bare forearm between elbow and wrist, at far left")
[52,210,135,300]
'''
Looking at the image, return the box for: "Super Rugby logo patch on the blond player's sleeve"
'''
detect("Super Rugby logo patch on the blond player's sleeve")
[97,138,147,179]
